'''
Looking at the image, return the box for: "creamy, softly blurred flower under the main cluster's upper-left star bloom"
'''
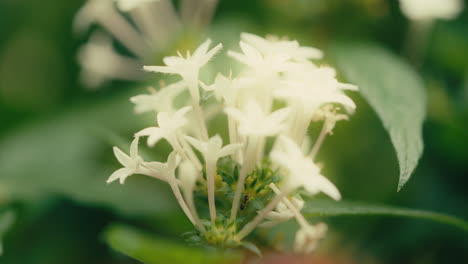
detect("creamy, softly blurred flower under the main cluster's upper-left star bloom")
[130,82,185,113]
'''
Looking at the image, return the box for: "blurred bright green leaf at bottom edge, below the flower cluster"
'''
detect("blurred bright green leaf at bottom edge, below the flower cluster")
[104,225,241,264]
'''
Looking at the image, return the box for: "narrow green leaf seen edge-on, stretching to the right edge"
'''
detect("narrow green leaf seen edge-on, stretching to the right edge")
[302,199,468,232]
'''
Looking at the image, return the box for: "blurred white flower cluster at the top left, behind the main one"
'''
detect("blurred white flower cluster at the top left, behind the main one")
[73,0,217,88]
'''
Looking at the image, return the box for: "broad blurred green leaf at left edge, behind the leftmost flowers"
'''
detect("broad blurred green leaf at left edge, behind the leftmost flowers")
[0,91,176,216]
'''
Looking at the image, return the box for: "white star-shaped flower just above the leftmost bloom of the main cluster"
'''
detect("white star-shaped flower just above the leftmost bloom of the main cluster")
[135,107,191,150]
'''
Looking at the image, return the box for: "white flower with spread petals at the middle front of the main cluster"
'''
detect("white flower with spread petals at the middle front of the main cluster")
[225,100,289,136]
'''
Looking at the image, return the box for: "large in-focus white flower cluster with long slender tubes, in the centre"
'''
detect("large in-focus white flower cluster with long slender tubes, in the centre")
[108,33,357,252]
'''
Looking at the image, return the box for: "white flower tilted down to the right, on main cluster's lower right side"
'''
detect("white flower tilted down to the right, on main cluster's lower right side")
[270,136,341,200]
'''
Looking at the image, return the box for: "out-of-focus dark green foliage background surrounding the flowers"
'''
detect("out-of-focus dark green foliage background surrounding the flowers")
[0,0,468,264]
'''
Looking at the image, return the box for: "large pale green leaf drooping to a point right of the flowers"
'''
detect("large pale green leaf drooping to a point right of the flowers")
[332,44,426,190]
